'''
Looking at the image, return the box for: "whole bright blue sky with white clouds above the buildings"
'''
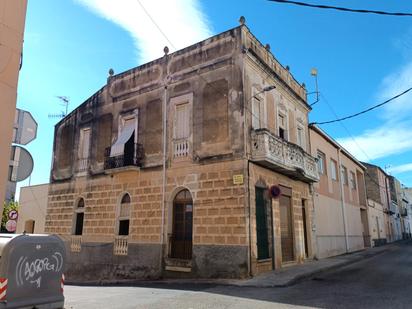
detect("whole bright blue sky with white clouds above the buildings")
[17,0,412,190]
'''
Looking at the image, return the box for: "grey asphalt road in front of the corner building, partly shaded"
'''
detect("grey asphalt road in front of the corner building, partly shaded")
[65,242,412,309]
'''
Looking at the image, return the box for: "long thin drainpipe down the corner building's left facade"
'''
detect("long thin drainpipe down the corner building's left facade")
[159,46,169,272]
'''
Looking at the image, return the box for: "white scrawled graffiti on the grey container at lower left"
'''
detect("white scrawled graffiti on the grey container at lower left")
[16,252,63,288]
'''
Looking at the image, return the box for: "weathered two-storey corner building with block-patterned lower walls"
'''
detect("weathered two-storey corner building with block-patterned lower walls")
[46,25,319,280]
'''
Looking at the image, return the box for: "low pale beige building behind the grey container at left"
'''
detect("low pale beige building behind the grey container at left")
[16,183,49,234]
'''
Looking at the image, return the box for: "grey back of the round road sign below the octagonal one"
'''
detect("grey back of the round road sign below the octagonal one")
[9,146,34,182]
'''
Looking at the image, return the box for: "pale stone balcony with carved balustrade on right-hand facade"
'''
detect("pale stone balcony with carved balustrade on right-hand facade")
[251,129,319,183]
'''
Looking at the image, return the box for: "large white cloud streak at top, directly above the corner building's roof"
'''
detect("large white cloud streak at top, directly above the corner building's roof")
[75,0,212,63]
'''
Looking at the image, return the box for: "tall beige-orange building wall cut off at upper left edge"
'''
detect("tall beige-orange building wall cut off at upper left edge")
[0,0,27,208]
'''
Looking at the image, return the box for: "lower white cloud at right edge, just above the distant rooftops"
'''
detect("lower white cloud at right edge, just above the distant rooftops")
[338,124,412,161]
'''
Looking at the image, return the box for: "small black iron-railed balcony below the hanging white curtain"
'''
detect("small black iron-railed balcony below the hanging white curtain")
[104,143,144,170]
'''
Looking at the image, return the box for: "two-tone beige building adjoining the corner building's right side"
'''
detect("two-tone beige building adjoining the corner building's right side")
[309,125,370,258]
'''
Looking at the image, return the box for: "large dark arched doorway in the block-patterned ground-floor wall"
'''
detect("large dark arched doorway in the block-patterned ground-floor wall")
[170,190,193,260]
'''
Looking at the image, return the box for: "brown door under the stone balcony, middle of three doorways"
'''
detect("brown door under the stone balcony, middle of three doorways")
[279,195,294,262]
